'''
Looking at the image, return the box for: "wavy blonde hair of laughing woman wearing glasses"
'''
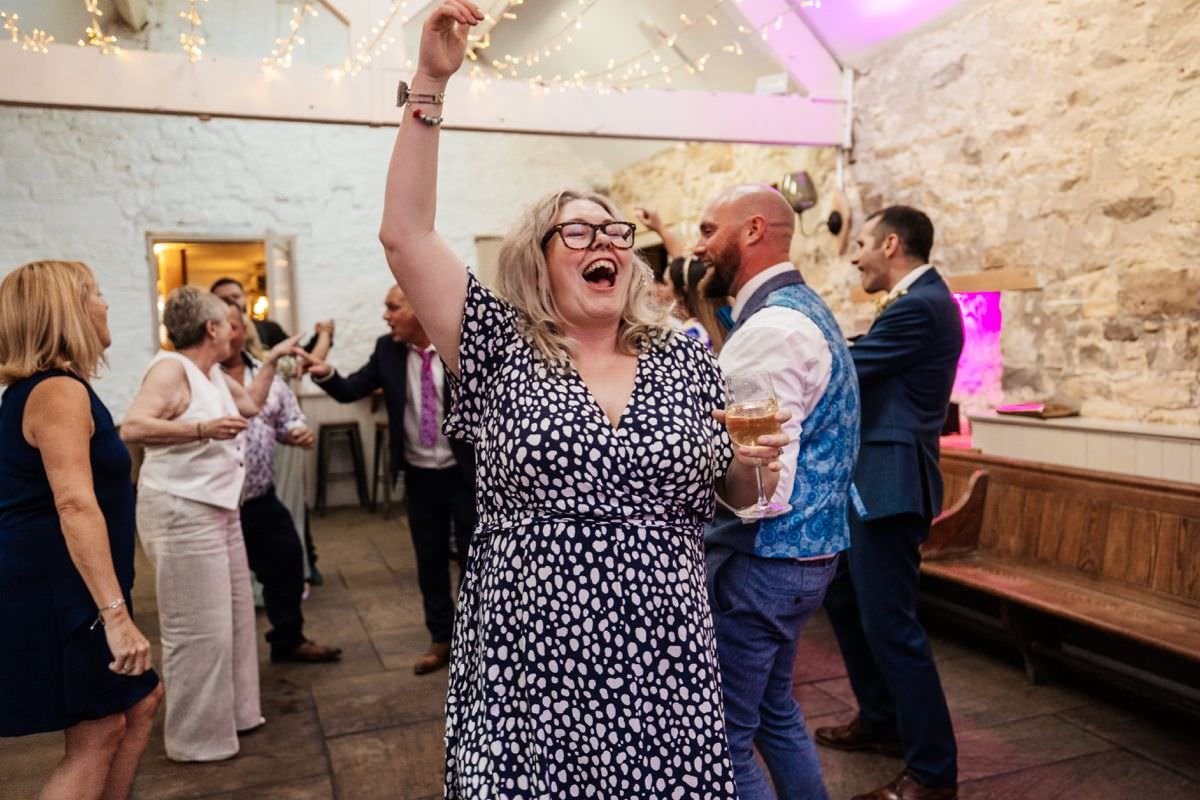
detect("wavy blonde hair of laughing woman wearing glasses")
[496,190,671,368]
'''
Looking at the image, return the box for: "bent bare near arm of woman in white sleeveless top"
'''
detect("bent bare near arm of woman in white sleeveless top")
[121,360,246,445]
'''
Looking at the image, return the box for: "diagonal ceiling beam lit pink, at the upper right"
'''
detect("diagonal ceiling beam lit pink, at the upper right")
[733,0,845,102]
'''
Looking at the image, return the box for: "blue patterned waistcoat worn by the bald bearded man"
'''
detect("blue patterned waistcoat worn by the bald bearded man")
[704,272,859,559]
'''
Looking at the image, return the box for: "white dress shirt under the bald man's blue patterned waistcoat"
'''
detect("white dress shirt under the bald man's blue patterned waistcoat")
[718,261,833,513]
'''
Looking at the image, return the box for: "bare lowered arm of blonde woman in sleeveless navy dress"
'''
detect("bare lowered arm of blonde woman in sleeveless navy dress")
[22,378,150,675]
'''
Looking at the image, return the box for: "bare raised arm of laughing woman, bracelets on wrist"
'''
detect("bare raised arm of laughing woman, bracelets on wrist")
[379,0,484,374]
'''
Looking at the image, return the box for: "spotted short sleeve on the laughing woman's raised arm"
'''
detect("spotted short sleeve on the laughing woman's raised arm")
[443,272,517,443]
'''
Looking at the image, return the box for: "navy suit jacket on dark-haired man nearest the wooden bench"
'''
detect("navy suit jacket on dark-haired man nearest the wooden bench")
[850,270,962,521]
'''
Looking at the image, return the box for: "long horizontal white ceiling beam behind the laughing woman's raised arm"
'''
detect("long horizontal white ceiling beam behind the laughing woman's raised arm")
[0,43,844,146]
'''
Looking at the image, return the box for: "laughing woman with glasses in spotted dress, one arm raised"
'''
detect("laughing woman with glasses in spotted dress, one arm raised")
[380,0,786,799]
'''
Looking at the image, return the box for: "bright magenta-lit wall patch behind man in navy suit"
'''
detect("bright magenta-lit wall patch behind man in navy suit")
[954,291,1003,410]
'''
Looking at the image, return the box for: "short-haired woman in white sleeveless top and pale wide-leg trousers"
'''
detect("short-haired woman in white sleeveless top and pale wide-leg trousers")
[121,287,295,762]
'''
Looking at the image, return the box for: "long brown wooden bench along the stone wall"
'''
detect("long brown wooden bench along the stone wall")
[922,451,1200,711]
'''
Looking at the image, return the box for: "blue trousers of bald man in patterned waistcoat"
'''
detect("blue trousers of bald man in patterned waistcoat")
[707,547,838,800]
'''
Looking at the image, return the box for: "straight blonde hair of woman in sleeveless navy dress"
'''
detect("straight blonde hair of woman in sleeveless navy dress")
[0,260,104,386]
